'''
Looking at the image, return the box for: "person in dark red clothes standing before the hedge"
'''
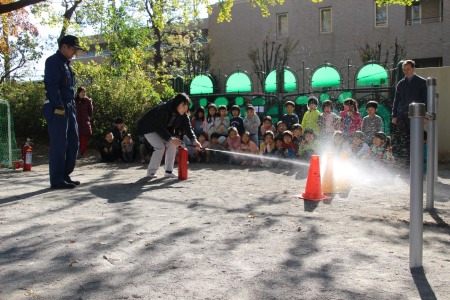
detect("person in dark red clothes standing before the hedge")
[75,86,94,156]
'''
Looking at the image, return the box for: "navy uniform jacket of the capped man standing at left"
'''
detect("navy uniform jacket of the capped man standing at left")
[44,50,75,112]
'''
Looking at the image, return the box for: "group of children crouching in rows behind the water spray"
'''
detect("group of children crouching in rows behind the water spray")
[185,97,395,167]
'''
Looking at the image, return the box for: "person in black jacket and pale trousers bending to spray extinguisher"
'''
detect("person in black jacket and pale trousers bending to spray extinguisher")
[138,93,201,178]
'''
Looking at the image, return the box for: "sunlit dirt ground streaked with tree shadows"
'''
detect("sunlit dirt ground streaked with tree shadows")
[0,148,450,299]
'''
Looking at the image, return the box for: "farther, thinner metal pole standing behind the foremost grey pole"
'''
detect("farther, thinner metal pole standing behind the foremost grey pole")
[426,77,437,210]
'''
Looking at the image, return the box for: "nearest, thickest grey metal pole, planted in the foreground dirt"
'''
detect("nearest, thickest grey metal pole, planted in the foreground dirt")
[409,103,425,268]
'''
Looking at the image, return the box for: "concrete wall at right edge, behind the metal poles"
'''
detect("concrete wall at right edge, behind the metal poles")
[416,67,450,162]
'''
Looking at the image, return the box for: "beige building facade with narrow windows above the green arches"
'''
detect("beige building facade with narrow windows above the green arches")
[208,0,450,79]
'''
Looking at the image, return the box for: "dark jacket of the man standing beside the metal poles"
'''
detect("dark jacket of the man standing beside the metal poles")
[392,74,427,118]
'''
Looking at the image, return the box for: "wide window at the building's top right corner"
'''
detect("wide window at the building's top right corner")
[406,0,443,26]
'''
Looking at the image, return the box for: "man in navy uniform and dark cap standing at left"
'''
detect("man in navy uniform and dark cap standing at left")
[42,35,83,189]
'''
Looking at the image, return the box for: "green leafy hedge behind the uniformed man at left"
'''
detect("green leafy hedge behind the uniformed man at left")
[1,63,178,146]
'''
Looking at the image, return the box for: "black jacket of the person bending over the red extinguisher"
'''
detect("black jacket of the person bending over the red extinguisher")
[138,99,197,141]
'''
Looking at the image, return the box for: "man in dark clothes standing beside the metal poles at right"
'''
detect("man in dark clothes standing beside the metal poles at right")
[392,60,427,163]
